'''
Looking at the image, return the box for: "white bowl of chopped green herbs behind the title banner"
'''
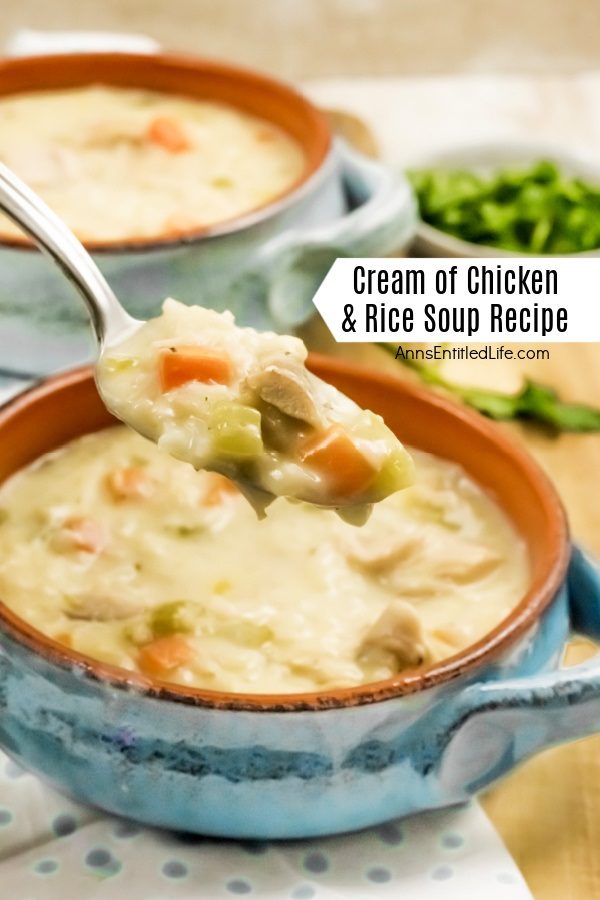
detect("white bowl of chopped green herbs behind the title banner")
[408,142,600,257]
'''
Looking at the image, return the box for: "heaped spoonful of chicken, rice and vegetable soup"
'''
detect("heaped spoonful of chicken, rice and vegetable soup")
[96,300,413,507]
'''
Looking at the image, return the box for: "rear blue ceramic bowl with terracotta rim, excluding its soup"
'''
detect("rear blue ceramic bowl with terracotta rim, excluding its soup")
[0,53,417,374]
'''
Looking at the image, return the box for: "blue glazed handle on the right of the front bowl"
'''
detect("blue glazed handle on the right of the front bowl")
[436,548,600,794]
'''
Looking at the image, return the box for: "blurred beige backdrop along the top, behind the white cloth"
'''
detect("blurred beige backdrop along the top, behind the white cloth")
[0,0,600,79]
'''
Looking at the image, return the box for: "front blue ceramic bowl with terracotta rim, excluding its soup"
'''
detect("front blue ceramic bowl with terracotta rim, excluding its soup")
[0,357,600,838]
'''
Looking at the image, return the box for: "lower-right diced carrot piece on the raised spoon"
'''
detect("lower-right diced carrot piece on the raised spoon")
[300,425,375,497]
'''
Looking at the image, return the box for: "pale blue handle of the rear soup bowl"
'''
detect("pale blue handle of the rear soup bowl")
[256,138,417,329]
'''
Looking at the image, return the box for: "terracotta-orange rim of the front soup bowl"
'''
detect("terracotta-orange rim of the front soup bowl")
[0,355,570,712]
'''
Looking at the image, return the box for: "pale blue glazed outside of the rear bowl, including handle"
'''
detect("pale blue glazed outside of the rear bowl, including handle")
[0,139,417,375]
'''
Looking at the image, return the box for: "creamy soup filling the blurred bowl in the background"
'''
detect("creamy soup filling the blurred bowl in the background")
[0,86,306,241]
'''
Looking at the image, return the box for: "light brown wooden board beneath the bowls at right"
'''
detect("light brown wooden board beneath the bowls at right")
[314,111,600,900]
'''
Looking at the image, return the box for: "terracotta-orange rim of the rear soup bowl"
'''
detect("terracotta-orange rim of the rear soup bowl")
[0,53,333,254]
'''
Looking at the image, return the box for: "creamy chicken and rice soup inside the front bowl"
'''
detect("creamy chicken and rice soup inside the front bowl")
[0,426,528,693]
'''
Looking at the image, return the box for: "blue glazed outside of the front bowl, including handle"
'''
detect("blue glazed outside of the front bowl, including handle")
[0,550,600,838]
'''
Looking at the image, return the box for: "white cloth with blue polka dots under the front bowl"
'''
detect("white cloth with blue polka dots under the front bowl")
[0,753,531,900]
